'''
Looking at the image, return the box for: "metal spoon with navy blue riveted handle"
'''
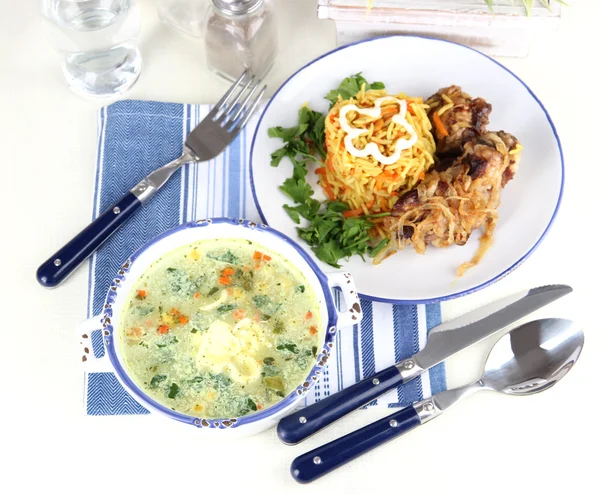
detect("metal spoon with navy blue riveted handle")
[291,319,583,483]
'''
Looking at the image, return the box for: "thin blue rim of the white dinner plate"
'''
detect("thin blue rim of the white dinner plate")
[249,34,565,304]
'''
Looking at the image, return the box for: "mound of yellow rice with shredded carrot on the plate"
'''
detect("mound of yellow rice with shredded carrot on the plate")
[316,85,436,243]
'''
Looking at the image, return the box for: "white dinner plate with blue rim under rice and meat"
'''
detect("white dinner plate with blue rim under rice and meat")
[250,36,564,303]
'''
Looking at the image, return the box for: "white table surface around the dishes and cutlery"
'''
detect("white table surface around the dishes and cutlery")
[0,0,600,494]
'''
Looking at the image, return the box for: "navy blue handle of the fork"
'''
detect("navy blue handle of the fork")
[36,192,142,288]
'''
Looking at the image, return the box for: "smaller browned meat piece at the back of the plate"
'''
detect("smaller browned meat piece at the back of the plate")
[425,86,492,158]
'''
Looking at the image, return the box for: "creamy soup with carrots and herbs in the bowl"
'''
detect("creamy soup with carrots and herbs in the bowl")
[120,239,322,418]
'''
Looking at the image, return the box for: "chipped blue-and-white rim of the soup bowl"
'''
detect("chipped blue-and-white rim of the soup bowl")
[102,217,338,429]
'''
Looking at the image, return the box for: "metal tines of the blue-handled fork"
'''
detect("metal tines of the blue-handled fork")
[210,70,267,132]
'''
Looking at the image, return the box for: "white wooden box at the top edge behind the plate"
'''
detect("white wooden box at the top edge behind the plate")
[318,0,561,57]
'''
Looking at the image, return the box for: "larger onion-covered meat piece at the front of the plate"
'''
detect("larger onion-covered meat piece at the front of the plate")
[386,132,521,276]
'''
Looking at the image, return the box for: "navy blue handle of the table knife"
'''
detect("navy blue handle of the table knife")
[277,366,402,444]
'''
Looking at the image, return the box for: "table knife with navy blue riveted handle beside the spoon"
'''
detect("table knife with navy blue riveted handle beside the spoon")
[277,285,573,444]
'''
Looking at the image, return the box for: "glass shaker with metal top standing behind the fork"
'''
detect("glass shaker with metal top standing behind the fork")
[204,0,277,81]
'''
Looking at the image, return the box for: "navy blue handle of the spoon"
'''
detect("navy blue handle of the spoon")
[290,406,421,484]
